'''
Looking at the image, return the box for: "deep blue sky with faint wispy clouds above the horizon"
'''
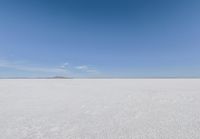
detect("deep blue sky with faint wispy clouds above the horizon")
[0,0,200,77]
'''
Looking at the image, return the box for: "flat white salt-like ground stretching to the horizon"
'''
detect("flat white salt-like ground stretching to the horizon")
[0,79,200,139]
